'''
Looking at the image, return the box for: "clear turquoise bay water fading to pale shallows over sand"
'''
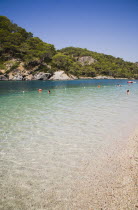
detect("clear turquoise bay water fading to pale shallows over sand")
[0,80,138,209]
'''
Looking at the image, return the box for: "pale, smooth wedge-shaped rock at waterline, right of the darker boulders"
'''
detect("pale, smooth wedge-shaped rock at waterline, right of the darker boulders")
[50,71,77,80]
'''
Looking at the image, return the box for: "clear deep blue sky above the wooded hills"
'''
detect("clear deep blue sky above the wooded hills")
[0,0,138,62]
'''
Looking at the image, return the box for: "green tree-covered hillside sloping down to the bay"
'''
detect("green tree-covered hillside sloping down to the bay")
[0,16,138,78]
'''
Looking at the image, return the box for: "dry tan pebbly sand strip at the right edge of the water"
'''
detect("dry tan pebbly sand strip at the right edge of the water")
[110,130,138,210]
